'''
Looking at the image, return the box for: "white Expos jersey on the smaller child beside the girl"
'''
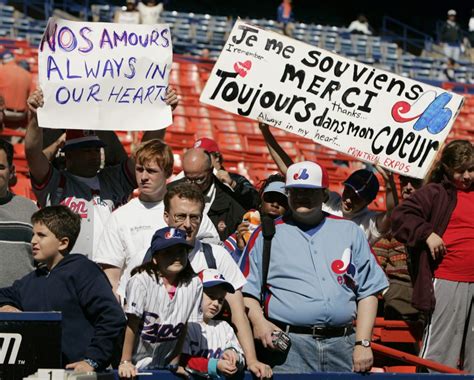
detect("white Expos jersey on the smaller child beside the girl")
[183,319,244,359]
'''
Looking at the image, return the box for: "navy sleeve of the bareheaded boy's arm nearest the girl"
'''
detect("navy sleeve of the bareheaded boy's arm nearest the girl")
[76,262,126,369]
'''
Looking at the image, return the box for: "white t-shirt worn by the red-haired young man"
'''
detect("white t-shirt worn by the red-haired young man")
[93,198,219,299]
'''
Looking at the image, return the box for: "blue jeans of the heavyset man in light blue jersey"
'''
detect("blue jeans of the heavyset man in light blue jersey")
[268,333,355,373]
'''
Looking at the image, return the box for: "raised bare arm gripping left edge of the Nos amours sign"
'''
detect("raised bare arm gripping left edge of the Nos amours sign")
[25,89,50,183]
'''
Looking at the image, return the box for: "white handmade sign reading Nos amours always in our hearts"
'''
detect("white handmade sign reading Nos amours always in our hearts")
[38,18,173,131]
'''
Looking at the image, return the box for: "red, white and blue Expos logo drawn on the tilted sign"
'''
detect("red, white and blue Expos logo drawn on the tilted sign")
[392,92,453,135]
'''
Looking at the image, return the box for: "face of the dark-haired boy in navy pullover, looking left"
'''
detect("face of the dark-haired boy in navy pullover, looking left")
[31,223,68,263]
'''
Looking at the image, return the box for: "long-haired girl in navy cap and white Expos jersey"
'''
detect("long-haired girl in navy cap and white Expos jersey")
[119,227,202,377]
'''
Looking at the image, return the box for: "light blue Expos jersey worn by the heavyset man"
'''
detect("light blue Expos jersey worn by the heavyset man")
[241,217,388,326]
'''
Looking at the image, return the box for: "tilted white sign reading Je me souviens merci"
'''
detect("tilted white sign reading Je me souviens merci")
[200,21,463,178]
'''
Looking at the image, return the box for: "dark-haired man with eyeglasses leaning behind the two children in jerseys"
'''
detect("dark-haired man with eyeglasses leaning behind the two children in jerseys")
[162,182,269,378]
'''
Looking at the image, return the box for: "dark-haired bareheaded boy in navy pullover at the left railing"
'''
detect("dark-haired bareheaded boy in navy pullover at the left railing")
[0,206,125,372]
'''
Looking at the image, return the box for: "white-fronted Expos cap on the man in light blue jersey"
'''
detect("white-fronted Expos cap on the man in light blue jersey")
[285,161,329,189]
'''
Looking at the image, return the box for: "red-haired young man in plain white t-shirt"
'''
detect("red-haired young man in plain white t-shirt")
[93,139,219,299]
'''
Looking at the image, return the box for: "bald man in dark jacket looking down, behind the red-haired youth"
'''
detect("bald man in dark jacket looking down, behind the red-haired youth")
[179,148,246,240]
